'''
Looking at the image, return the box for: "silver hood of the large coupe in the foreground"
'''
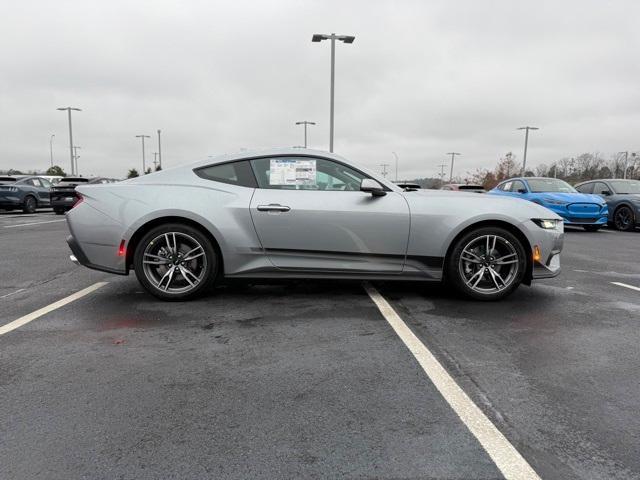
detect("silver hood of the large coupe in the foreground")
[403,190,561,221]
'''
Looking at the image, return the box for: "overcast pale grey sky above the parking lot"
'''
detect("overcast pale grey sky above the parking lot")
[0,0,640,178]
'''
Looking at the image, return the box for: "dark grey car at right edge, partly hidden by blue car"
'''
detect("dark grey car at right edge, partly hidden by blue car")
[576,179,640,232]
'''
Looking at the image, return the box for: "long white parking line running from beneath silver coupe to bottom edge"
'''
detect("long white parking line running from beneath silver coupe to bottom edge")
[365,284,540,480]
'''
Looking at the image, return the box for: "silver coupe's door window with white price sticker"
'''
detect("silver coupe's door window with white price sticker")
[251,157,368,191]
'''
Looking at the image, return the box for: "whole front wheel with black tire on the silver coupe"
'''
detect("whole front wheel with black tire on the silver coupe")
[445,227,527,301]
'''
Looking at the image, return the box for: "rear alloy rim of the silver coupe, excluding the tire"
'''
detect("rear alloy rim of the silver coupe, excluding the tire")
[142,232,207,294]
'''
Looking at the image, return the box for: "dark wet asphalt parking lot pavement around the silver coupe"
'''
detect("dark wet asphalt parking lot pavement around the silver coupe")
[0,222,640,479]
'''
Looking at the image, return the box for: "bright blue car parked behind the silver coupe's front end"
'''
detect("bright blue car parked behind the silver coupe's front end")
[489,177,609,232]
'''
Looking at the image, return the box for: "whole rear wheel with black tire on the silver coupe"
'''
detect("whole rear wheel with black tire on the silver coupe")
[133,223,220,301]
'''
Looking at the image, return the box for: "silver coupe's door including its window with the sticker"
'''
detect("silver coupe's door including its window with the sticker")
[251,156,409,273]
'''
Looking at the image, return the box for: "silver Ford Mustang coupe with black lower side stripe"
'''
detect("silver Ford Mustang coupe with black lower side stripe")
[67,149,563,300]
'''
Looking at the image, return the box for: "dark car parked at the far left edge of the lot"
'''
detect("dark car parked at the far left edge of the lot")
[0,176,51,213]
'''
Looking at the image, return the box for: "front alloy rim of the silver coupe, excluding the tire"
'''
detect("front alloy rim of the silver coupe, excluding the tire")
[458,235,520,295]
